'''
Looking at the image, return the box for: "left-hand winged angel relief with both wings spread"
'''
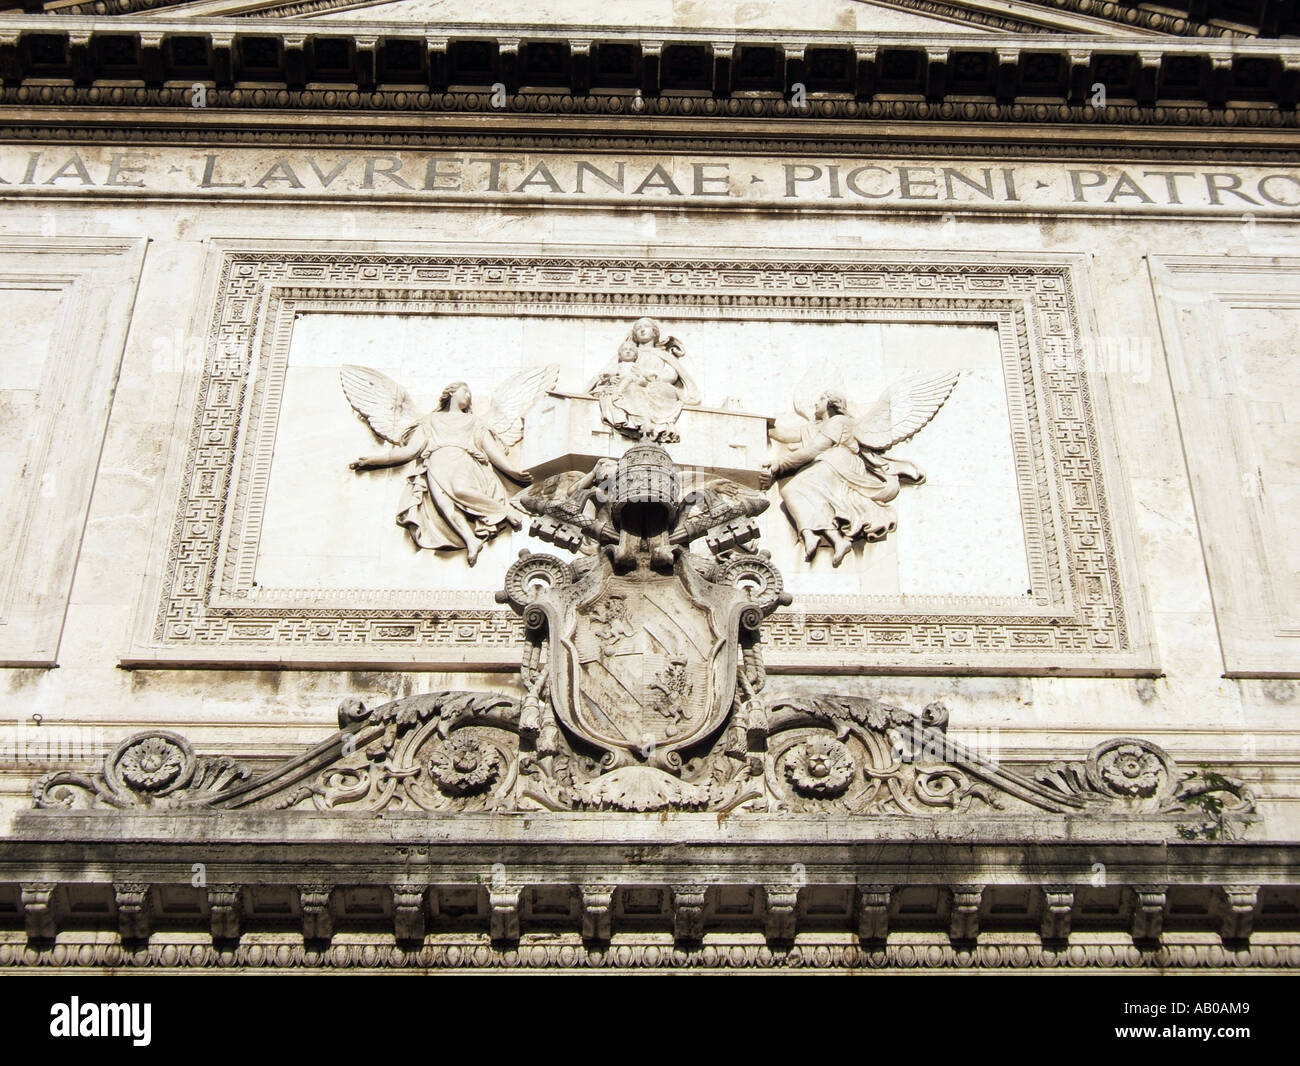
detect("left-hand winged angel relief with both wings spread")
[339,365,559,566]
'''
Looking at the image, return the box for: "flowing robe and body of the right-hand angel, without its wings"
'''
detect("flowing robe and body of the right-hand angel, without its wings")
[781,415,898,541]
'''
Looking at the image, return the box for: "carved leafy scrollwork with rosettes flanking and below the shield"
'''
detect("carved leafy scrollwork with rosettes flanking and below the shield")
[35,692,1256,840]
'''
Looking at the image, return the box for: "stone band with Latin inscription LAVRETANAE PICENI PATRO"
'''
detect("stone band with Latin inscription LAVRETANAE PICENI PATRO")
[0,146,1300,216]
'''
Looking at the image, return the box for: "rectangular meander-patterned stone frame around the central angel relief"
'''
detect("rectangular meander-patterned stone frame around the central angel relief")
[124,241,1153,675]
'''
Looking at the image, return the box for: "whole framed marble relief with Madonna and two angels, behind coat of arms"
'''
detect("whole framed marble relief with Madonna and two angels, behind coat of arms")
[131,241,1153,673]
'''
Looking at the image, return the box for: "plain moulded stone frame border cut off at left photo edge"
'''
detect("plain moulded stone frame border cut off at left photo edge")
[0,235,144,667]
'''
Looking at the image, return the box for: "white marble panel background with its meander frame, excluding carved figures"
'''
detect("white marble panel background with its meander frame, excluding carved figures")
[131,242,1149,673]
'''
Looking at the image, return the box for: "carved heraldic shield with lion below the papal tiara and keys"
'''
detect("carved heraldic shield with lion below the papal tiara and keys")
[512,553,753,768]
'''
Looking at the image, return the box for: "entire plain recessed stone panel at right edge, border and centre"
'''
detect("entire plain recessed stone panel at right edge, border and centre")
[1152,256,1300,677]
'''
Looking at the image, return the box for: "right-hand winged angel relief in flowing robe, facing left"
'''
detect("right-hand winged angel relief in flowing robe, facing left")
[763,373,958,567]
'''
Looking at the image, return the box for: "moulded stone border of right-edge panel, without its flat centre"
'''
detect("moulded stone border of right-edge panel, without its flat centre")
[1151,255,1300,677]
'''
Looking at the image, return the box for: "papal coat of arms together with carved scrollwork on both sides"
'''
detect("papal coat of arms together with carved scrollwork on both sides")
[35,441,1255,840]
